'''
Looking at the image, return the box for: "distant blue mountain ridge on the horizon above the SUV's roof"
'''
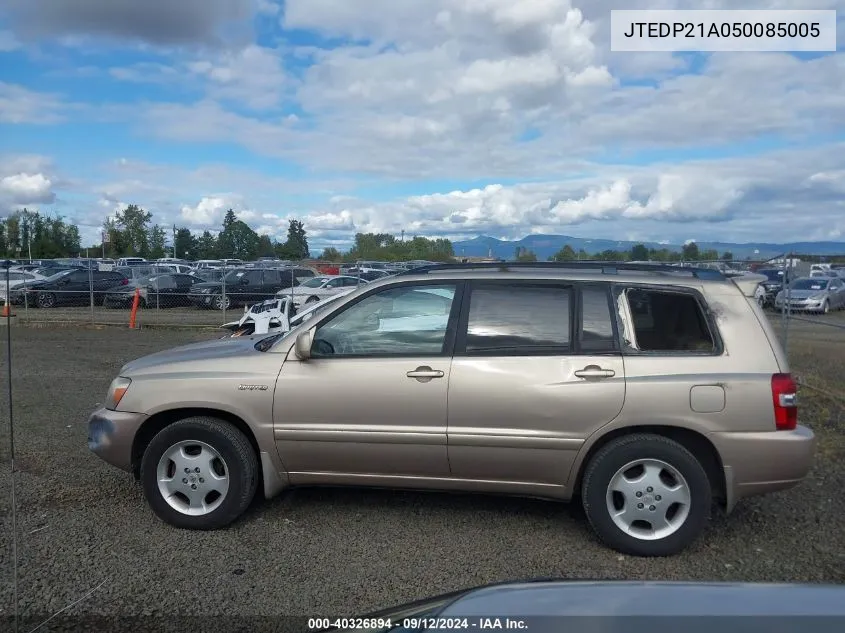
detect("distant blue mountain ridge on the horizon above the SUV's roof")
[452,235,845,261]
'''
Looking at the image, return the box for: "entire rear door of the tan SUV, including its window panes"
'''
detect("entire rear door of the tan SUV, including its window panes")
[448,282,625,486]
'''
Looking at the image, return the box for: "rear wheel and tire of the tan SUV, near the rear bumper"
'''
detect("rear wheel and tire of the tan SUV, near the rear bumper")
[581,433,713,556]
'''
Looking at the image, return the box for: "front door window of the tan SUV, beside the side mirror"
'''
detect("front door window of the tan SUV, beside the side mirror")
[312,284,456,357]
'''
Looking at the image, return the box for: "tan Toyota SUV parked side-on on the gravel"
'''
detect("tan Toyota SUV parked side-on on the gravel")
[89,263,815,556]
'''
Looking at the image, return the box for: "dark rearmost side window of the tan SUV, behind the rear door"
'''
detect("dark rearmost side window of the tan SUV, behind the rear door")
[626,288,716,353]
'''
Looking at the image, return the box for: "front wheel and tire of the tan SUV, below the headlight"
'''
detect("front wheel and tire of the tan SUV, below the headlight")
[141,417,259,530]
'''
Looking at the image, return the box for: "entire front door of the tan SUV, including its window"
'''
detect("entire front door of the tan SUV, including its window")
[273,282,461,483]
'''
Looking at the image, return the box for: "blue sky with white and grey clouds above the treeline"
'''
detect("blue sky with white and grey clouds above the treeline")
[0,0,845,251]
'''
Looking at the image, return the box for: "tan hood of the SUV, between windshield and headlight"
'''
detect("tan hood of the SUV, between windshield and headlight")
[120,334,267,378]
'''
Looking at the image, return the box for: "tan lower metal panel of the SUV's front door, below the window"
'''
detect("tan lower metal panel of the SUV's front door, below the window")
[274,356,450,476]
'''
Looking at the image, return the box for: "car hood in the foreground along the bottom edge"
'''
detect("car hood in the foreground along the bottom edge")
[334,581,845,633]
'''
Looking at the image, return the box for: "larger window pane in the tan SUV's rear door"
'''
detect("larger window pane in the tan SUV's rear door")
[466,283,572,356]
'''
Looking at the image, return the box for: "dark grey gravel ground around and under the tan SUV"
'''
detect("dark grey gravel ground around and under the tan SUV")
[0,316,845,617]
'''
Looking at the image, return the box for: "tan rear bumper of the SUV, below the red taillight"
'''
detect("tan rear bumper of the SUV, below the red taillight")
[708,426,816,512]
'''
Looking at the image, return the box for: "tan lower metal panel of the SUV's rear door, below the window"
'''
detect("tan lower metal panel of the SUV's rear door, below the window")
[448,355,625,485]
